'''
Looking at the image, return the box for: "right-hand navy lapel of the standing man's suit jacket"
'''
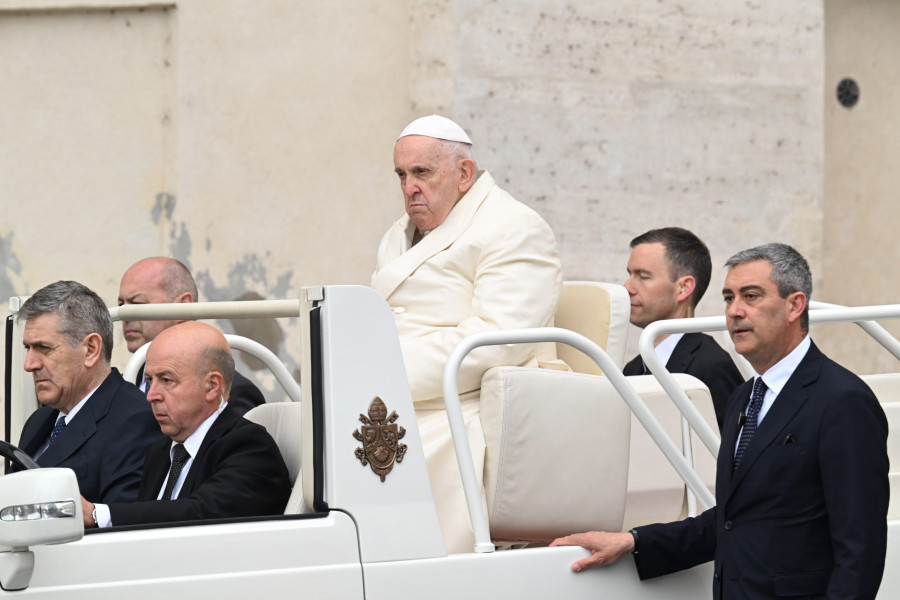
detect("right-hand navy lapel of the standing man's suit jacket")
[728,343,824,492]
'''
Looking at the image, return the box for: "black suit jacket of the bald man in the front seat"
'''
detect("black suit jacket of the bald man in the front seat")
[109,405,291,525]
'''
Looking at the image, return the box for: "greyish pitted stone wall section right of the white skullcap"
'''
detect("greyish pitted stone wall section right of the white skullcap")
[413,0,824,356]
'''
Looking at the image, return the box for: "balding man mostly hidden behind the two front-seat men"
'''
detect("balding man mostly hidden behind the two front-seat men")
[119,256,266,415]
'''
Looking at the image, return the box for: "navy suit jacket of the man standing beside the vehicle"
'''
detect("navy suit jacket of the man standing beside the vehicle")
[635,344,889,600]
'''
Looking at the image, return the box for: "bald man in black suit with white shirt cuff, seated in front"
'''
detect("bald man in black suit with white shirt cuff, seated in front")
[82,322,291,527]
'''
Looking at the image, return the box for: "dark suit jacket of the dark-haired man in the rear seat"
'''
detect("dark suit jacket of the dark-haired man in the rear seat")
[622,333,744,432]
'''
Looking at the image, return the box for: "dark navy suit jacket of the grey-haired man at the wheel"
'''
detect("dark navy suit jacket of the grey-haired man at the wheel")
[19,369,163,503]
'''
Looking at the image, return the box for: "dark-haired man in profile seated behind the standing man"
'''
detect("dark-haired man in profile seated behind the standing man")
[623,227,744,431]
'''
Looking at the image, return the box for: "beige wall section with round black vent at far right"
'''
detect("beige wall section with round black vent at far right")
[814,0,900,373]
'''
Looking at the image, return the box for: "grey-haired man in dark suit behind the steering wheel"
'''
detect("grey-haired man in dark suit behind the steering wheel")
[18,281,161,502]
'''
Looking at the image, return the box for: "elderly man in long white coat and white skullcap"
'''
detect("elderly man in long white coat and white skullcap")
[372,115,562,553]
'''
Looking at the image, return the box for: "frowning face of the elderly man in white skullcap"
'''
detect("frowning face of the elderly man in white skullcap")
[394,135,464,232]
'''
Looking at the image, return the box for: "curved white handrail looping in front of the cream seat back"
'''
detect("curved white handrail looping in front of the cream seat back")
[444,327,716,552]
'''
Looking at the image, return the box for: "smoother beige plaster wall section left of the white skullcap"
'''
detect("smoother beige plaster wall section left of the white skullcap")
[0,0,411,394]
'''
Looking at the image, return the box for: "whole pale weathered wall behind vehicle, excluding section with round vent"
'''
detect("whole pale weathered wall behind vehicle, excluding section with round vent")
[0,0,864,408]
